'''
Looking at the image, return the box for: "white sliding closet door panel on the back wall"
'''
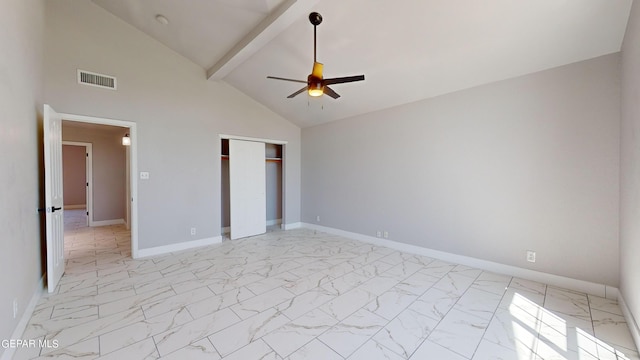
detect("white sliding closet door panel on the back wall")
[229,139,267,239]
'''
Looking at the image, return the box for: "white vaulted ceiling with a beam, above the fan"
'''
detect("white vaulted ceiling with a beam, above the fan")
[93,0,632,127]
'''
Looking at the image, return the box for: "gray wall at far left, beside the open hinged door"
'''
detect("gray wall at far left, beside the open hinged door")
[0,0,44,354]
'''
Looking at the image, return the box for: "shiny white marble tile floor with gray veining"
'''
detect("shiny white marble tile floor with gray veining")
[14,221,640,360]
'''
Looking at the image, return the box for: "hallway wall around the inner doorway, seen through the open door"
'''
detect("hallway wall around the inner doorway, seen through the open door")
[62,126,127,221]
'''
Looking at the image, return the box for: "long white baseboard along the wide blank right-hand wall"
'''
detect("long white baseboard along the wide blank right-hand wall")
[302,223,618,299]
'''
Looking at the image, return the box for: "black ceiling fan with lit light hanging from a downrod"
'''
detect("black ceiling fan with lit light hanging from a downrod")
[267,12,364,99]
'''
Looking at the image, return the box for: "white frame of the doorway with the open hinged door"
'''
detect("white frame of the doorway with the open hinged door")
[59,113,138,259]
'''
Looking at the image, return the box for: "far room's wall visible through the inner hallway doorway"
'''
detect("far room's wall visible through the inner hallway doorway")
[62,145,87,209]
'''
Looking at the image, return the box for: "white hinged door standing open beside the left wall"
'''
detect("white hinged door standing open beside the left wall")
[44,105,64,292]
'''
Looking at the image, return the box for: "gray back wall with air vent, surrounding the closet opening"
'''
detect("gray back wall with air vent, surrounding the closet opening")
[45,0,300,249]
